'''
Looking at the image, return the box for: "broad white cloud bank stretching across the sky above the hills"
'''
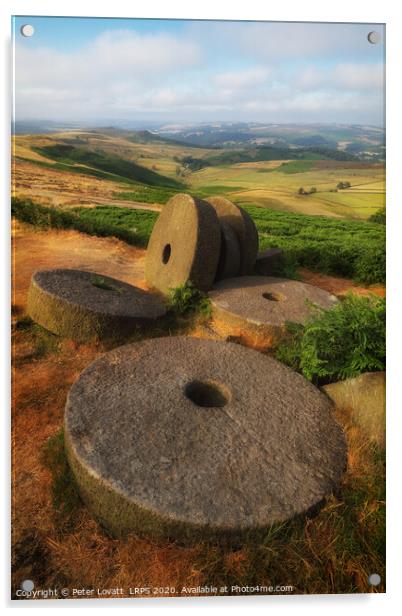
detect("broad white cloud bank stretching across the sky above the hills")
[16,23,383,123]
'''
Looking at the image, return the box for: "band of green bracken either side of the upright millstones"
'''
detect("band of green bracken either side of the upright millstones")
[12,198,385,284]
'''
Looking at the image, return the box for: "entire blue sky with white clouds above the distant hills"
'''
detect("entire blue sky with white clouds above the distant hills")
[13,16,385,126]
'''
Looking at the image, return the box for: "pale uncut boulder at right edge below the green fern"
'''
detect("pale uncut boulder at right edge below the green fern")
[322,372,385,447]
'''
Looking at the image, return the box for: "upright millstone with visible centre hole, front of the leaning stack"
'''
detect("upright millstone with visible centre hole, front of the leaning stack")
[145,193,221,293]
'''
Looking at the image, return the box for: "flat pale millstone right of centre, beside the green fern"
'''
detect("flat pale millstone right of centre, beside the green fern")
[209,276,338,346]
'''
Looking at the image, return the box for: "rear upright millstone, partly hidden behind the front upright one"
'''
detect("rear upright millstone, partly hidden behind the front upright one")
[206,197,258,276]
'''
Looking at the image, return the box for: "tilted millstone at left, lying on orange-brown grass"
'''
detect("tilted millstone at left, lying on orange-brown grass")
[27,269,166,342]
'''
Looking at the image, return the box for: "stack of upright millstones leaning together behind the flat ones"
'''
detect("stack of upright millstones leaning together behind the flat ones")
[145,193,258,294]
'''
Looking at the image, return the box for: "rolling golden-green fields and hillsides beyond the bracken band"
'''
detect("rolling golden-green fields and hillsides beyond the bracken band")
[14,129,385,220]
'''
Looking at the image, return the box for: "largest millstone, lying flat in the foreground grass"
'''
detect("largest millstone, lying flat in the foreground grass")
[65,337,346,541]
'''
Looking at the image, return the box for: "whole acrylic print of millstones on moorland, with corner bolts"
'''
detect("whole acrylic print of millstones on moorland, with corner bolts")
[12,16,385,600]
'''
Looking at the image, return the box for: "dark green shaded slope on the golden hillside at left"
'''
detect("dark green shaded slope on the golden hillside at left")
[31,144,183,188]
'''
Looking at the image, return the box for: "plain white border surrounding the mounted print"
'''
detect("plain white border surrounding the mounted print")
[0,0,402,616]
